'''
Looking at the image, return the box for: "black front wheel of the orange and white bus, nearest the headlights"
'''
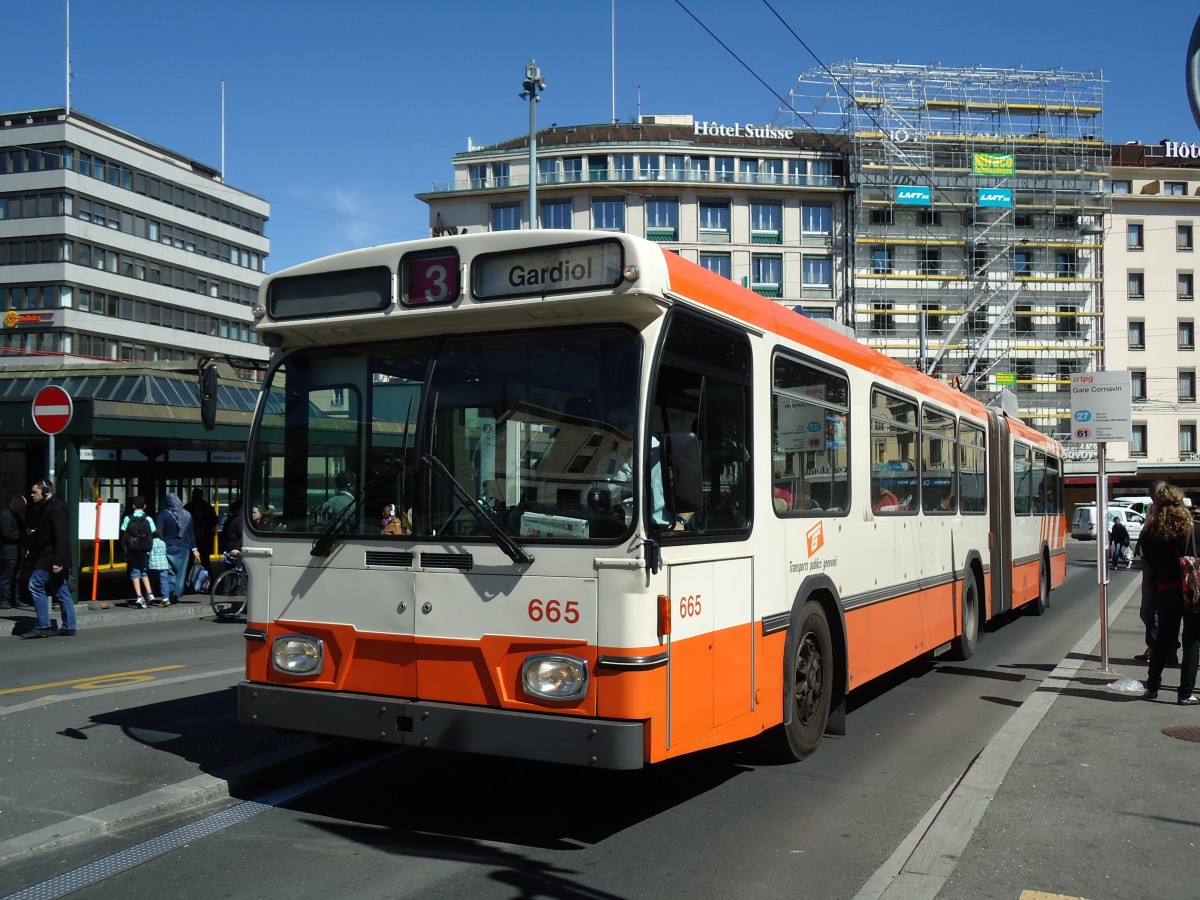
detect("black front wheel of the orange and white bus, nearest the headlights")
[780,601,834,760]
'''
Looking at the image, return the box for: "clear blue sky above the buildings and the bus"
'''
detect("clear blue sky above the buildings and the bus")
[9,0,1200,271]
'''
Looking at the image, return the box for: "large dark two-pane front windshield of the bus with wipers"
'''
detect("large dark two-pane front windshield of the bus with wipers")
[247,325,641,552]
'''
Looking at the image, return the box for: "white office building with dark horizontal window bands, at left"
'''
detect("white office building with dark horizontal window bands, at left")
[0,108,270,368]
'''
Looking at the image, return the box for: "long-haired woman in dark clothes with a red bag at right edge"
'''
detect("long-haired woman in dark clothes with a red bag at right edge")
[1139,485,1200,707]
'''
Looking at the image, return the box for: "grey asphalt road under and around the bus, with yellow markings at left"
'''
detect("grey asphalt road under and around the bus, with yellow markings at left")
[0,542,1139,900]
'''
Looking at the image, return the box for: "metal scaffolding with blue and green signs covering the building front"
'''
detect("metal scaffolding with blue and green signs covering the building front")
[776,61,1110,433]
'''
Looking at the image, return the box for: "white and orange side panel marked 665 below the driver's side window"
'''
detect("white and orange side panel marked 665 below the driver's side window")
[667,557,754,746]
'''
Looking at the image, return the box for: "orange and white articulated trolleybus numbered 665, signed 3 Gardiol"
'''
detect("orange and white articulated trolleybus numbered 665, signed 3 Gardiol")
[239,230,1066,769]
